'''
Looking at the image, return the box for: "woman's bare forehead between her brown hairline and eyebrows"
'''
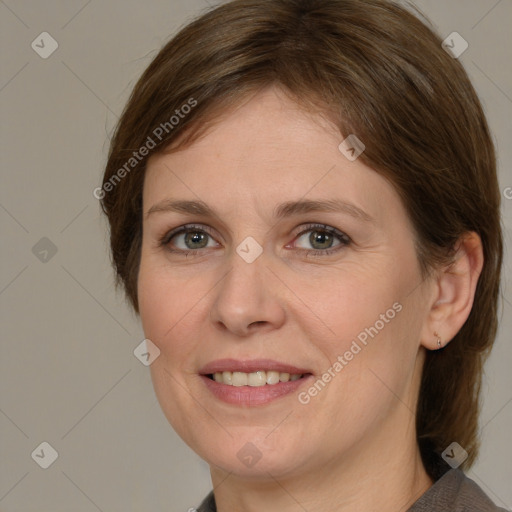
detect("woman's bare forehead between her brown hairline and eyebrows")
[144,89,403,228]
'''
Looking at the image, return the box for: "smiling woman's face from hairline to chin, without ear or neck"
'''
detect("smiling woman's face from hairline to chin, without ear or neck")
[138,89,432,477]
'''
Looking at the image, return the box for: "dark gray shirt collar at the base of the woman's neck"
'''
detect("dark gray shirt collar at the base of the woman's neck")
[197,469,507,512]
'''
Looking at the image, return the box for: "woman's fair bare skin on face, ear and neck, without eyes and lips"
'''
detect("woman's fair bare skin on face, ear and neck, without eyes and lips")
[138,88,482,512]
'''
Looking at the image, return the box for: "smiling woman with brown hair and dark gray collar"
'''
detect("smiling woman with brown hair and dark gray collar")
[99,0,502,512]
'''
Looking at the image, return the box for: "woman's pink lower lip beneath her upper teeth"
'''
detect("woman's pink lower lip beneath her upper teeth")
[201,375,313,406]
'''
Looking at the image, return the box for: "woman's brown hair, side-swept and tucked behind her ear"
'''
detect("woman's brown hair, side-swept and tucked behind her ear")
[100,0,503,479]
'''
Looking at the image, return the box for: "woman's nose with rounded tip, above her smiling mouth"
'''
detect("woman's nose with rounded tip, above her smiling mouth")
[210,251,286,337]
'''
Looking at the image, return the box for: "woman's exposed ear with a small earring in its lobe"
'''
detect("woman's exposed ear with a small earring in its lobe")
[421,231,484,350]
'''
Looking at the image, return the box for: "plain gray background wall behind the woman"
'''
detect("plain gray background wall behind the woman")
[0,0,512,512]
